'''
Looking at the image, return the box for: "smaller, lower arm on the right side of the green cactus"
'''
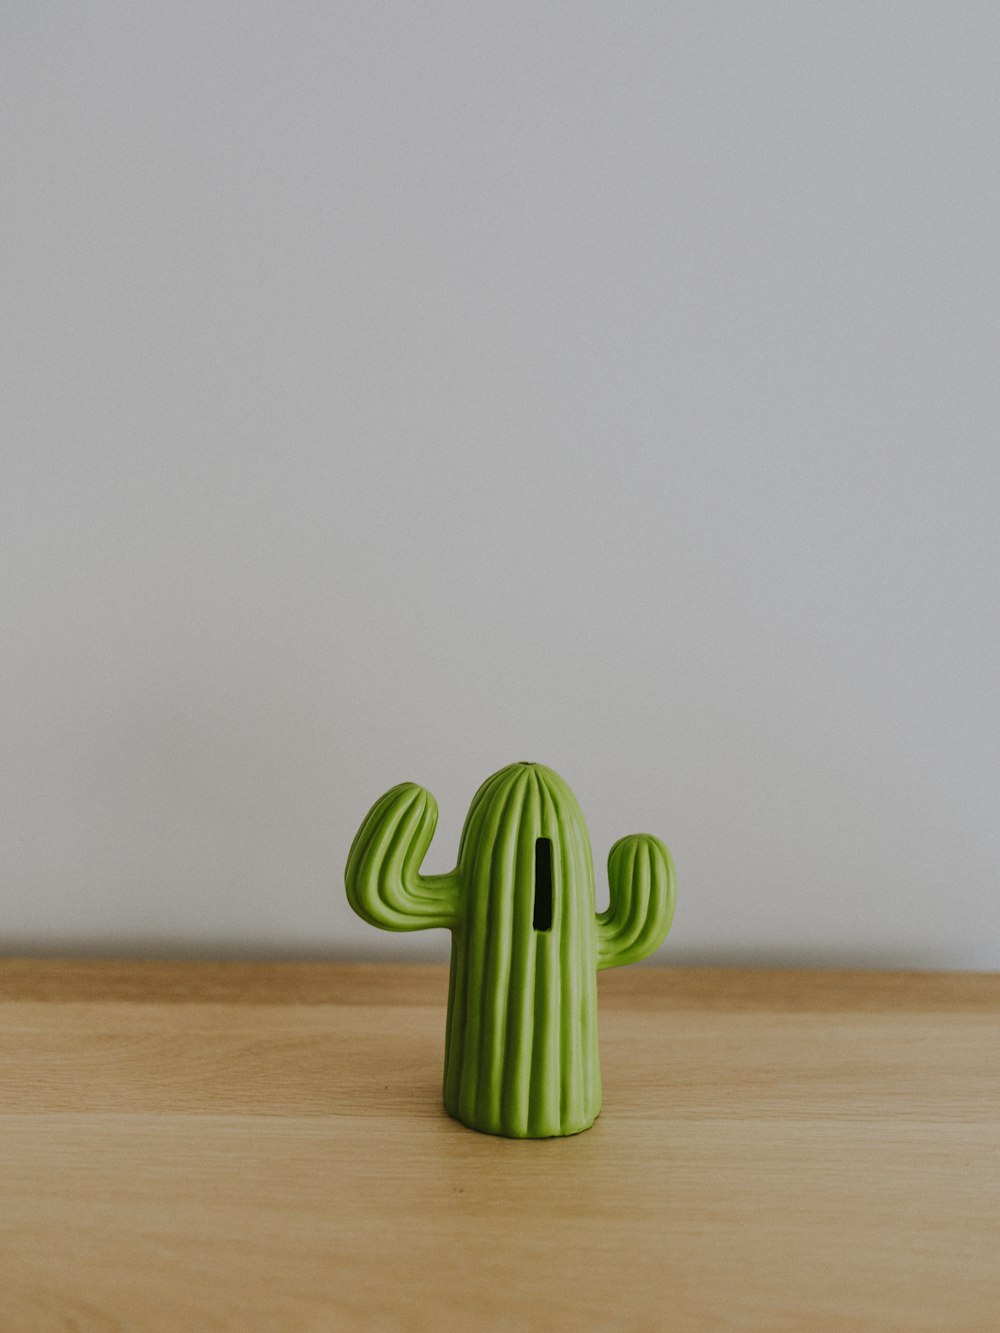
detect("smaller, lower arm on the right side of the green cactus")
[597,833,676,968]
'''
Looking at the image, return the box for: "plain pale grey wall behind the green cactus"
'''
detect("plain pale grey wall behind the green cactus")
[0,0,1000,968]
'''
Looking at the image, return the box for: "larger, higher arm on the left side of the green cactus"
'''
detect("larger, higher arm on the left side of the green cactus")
[344,782,459,930]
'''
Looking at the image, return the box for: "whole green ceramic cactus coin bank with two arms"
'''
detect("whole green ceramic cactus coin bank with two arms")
[345,762,675,1138]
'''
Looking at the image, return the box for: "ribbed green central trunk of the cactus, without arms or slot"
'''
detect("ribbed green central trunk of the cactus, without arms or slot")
[444,764,600,1138]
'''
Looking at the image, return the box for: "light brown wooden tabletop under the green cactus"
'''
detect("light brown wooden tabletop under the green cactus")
[0,960,1000,1333]
